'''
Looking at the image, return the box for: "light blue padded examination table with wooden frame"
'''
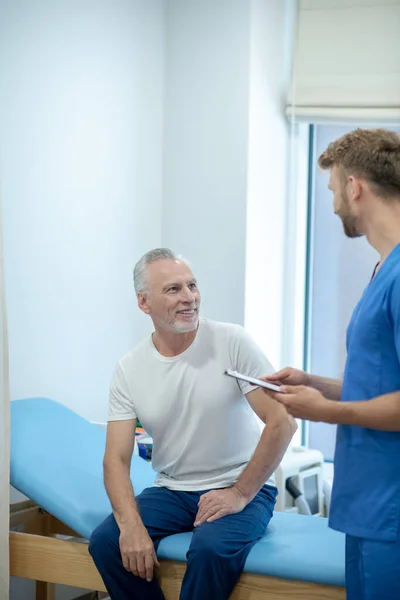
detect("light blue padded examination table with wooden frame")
[10,398,345,600]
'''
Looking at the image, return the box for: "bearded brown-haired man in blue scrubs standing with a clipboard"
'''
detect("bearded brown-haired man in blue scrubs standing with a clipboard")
[264,129,400,600]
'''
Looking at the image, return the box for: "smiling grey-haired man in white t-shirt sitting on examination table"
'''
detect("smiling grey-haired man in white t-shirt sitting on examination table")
[90,249,296,600]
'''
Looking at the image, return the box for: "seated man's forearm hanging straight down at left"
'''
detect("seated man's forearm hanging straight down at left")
[104,460,142,527]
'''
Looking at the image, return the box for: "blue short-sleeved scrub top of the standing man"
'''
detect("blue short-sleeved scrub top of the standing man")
[329,244,400,541]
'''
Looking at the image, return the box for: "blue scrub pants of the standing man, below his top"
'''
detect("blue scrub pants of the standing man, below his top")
[346,535,400,600]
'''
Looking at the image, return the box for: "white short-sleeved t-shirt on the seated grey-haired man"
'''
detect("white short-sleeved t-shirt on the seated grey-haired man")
[109,319,273,491]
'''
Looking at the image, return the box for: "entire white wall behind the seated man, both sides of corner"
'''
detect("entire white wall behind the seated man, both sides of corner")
[0,0,294,421]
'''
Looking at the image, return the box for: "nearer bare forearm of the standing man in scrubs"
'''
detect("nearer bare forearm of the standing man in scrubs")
[328,392,400,431]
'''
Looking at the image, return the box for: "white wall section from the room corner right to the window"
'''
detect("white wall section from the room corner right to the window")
[162,0,295,365]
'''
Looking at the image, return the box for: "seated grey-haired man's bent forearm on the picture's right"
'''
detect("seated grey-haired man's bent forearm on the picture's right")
[235,419,296,502]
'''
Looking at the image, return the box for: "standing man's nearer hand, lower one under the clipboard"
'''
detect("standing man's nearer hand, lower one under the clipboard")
[274,385,338,423]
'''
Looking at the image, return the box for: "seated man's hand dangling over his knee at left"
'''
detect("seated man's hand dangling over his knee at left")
[119,524,160,581]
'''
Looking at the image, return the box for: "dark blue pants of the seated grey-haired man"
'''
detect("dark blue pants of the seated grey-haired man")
[89,485,277,600]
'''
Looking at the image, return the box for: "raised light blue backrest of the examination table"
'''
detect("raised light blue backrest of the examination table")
[10,398,155,539]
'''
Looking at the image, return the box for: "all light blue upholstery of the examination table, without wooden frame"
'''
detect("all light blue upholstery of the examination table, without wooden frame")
[11,398,345,586]
